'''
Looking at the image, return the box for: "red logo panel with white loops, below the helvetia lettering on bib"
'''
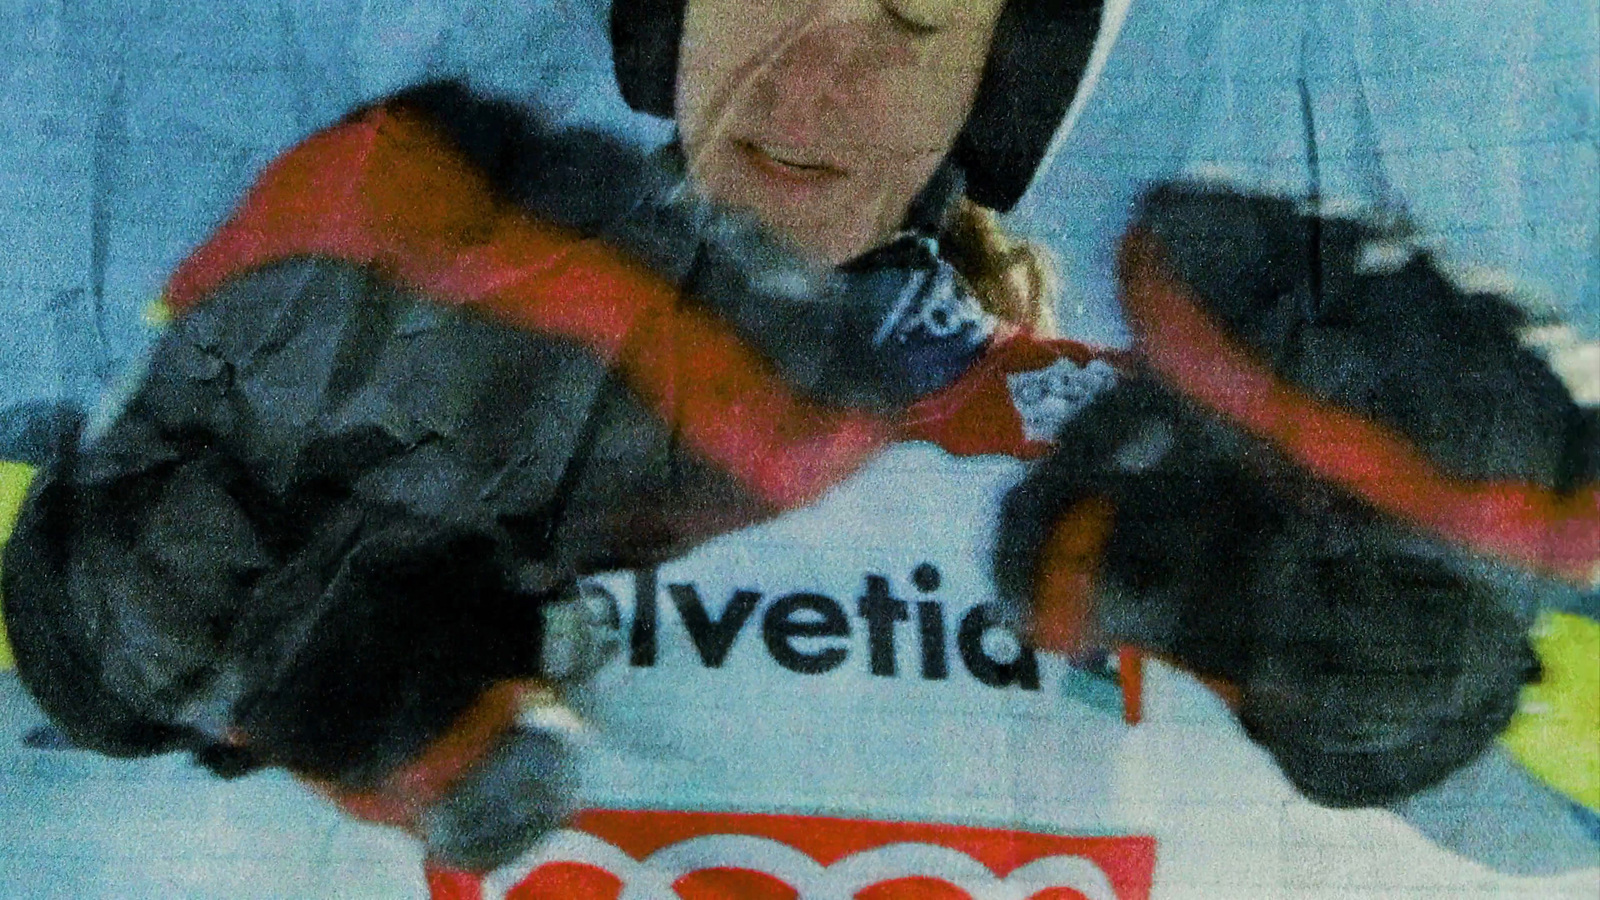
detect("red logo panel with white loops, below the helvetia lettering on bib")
[434,810,1155,900]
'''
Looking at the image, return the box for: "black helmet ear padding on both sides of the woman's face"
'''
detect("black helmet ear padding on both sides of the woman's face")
[611,0,1104,213]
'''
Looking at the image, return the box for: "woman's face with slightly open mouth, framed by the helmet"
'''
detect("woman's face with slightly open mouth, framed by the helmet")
[677,0,1005,263]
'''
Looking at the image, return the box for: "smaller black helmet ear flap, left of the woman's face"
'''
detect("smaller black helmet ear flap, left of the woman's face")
[611,0,685,119]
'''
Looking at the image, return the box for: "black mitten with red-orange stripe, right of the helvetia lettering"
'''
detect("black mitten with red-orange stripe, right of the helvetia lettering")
[995,178,1600,806]
